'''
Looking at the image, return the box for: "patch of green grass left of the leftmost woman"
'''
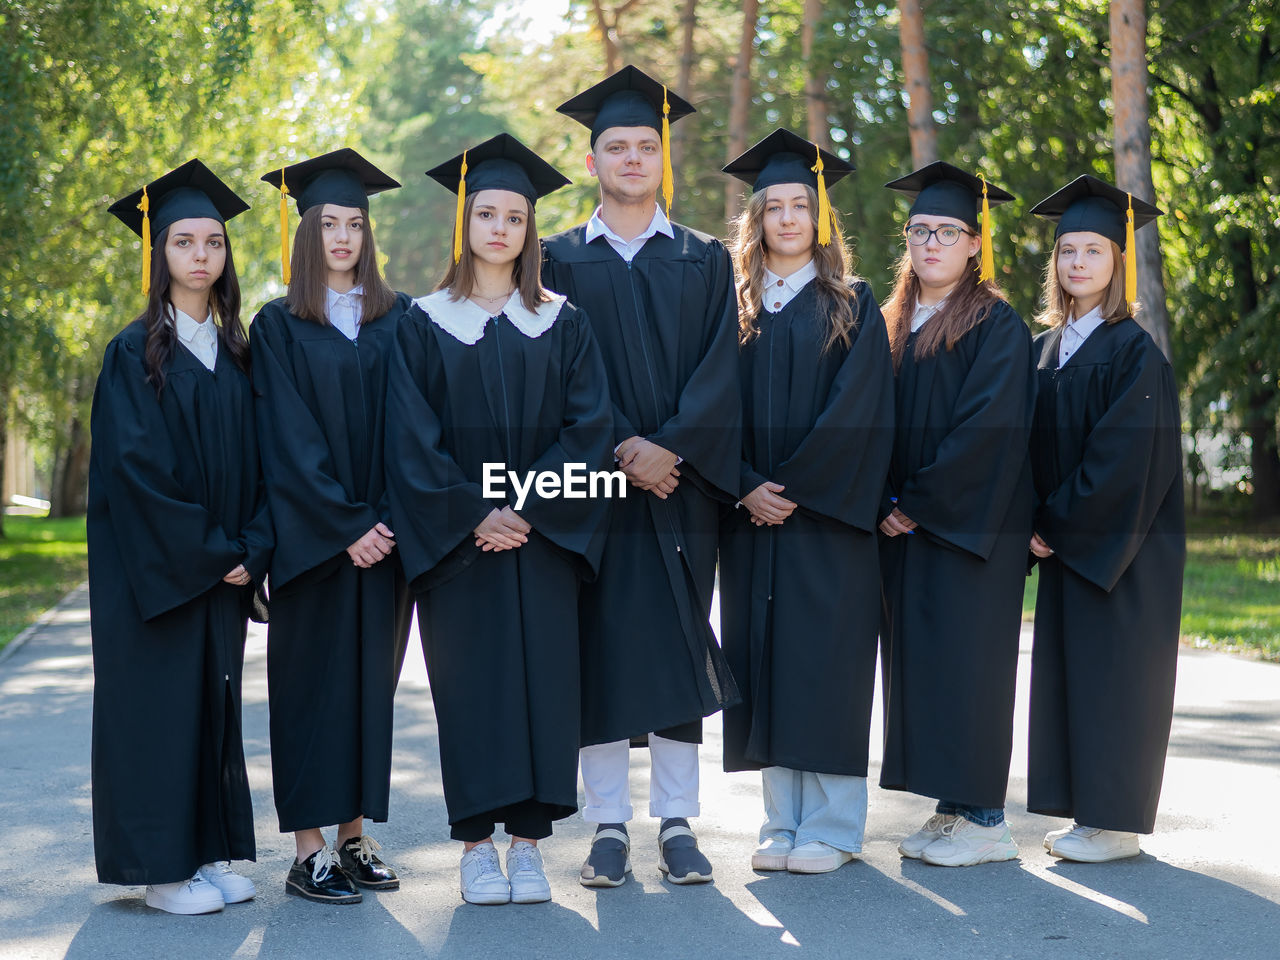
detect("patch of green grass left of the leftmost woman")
[0,517,88,649]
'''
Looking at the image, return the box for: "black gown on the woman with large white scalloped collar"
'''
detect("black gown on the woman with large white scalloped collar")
[388,293,613,823]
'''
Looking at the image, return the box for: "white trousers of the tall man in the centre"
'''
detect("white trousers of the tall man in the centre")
[579,733,700,823]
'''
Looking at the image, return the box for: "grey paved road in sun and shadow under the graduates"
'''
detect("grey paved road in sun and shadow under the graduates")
[0,590,1280,960]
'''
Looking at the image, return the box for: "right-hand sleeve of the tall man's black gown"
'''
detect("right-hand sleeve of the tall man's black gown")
[646,241,742,499]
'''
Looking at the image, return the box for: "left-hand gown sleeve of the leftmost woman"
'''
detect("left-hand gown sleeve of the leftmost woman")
[91,339,241,620]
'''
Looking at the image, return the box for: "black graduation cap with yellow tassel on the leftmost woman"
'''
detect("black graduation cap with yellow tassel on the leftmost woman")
[108,159,248,294]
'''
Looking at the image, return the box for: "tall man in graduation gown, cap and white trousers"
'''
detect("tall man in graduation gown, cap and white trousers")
[543,67,741,886]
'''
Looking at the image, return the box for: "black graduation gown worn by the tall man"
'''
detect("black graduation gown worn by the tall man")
[543,224,741,745]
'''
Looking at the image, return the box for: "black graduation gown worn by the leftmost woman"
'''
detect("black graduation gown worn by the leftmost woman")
[87,320,271,884]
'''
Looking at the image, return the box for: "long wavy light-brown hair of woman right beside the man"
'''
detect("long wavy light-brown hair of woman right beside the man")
[730,184,858,353]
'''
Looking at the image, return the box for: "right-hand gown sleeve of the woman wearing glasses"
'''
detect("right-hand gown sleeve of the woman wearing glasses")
[897,303,1036,559]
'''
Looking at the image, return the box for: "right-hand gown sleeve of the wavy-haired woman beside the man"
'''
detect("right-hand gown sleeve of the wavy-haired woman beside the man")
[774,284,893,532]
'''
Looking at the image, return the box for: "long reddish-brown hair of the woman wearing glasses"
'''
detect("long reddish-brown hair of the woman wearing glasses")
[882,250,1005,370]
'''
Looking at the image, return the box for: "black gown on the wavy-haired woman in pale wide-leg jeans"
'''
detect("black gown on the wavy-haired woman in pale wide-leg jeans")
[721,282,893,777]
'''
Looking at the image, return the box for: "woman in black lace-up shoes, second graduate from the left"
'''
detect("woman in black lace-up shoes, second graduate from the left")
[251,148,412,902]
